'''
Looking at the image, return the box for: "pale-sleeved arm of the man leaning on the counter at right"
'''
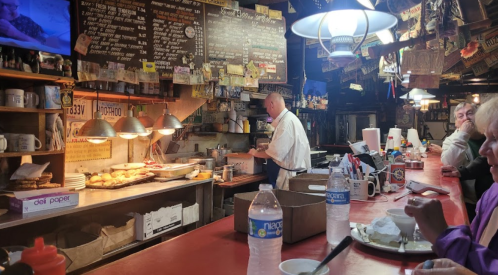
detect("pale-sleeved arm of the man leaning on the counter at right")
[441,131,470,167]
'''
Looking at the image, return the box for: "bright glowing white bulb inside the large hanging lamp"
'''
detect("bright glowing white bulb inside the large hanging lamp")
[328,10,358,37]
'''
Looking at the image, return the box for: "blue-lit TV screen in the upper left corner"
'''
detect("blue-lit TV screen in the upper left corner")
[0,0,71,55]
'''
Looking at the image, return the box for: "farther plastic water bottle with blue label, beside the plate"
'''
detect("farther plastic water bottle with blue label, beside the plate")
[327,167,351,246]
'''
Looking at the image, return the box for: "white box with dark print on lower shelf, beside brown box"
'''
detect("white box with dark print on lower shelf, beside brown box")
[133,203,183,241]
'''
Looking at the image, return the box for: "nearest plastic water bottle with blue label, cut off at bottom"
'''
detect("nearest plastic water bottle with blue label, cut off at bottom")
[247,184,283,275]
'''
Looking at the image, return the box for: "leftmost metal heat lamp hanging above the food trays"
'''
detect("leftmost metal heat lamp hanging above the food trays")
[78,90,116,144]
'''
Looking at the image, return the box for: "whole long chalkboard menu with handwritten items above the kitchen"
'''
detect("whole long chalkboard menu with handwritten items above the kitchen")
[77,0,287,83]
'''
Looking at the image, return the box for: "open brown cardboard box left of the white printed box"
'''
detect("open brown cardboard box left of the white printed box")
[100,216,135,254]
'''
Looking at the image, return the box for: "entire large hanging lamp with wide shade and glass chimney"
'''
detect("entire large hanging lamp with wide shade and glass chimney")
[291,0,398,67]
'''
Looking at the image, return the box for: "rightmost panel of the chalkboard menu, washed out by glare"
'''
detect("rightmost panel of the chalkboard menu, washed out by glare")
[205,5,287,83]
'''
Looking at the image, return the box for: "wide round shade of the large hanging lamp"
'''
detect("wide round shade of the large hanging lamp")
[291,0,398,39]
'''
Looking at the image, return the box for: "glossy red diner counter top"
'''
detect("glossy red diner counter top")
[87,156,468,275]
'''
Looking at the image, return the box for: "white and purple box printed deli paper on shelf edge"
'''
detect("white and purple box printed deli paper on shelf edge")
[9,192,79,214]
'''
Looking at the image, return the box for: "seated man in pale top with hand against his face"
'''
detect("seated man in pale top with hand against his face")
[441,102,493,221]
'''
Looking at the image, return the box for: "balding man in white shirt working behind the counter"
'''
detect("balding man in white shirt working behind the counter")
[249,93,311,190]
